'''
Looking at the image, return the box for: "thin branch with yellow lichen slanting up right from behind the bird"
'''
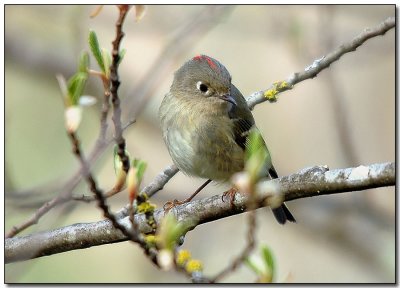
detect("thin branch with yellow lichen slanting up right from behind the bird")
[247,17,396,109]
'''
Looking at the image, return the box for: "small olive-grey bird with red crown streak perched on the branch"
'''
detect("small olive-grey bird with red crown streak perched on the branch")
[159,55,296,224]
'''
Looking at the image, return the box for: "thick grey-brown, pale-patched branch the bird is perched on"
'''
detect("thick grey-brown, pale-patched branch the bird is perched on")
[5,162,396,263]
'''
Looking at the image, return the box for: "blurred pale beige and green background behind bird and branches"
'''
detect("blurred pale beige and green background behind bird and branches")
[5,5,396,283]
